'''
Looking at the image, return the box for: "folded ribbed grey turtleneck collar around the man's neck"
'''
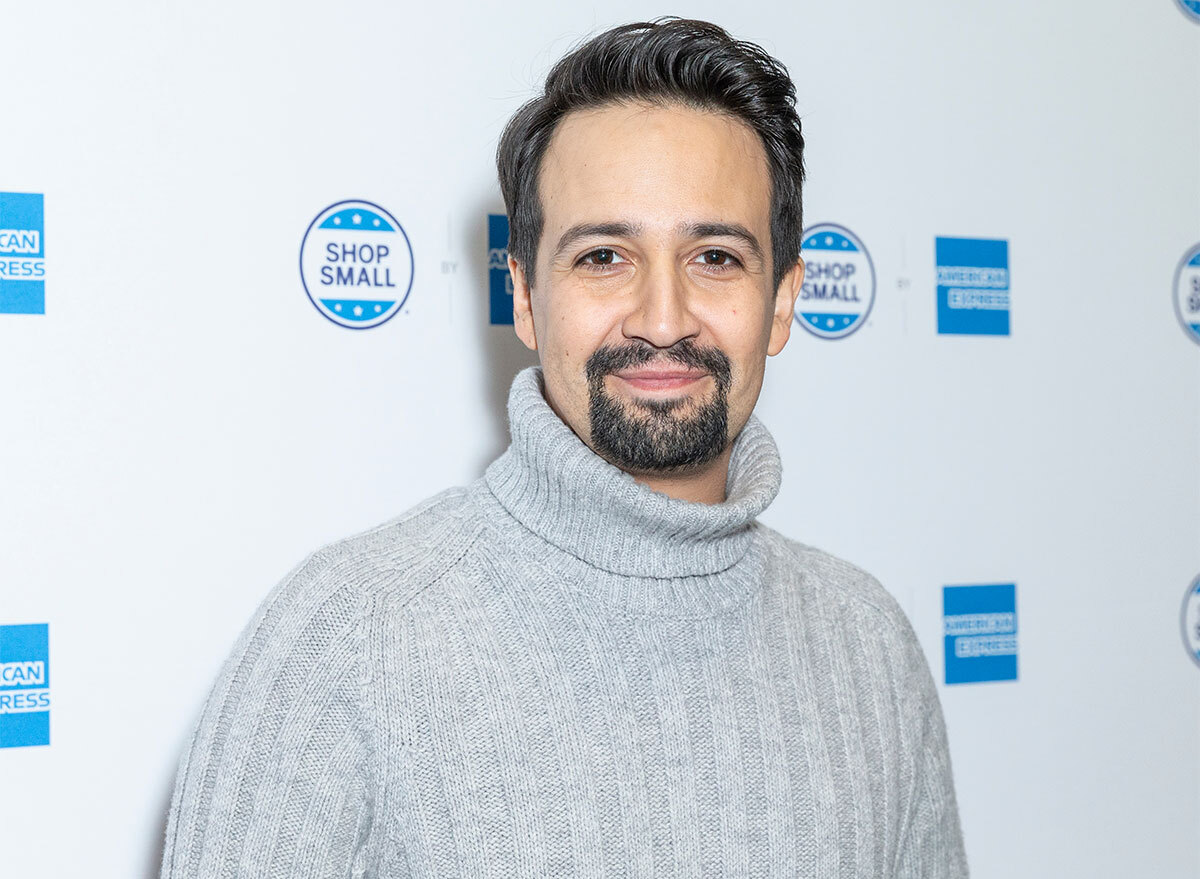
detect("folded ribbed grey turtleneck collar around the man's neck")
[484,366,781,578]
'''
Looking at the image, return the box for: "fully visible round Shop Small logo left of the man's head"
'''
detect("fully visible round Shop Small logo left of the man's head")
[300,199,413,329]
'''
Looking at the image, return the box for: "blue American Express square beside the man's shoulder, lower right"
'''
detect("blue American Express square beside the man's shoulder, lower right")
[942,582,1016,683]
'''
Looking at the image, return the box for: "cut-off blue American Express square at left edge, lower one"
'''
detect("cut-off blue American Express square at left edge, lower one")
[0,623,50,748]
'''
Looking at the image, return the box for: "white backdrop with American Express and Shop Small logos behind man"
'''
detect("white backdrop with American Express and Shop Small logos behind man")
[0,0,1200,879]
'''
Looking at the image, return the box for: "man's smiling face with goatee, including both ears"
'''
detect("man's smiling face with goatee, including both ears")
[509,103,803,474]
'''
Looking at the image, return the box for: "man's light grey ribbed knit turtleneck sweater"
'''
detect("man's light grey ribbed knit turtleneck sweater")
[163,369,967,879]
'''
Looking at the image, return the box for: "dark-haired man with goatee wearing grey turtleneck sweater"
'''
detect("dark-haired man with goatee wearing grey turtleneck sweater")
[163,19,966,879]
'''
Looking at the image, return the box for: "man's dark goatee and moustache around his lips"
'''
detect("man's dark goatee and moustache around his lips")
[586,339,732,473]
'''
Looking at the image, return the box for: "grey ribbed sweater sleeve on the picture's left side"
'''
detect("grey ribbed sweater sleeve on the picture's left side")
[162,556,372,879]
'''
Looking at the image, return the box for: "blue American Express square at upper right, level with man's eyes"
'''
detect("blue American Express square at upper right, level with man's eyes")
[936,238,1009,336]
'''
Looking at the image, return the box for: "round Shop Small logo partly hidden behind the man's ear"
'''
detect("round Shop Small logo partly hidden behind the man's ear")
[796,223,875,339]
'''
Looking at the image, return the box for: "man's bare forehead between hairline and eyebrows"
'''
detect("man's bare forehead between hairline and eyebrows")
[539,103,770,240]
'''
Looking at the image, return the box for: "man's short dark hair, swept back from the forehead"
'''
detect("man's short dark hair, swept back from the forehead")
[496,17,804,289]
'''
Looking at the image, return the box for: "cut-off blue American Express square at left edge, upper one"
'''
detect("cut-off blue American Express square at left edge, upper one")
[0,192,46,315]
